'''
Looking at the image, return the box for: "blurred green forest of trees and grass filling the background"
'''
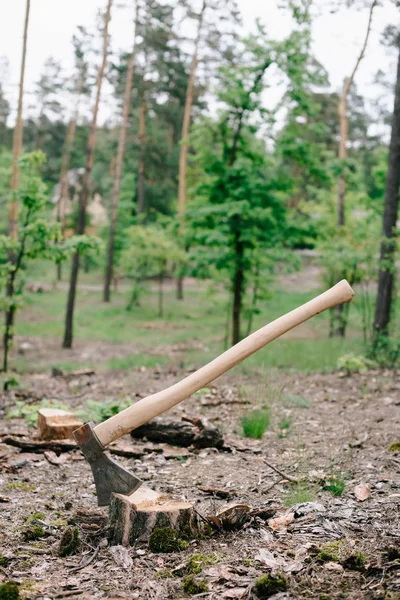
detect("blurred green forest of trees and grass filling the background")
[0,0,400,370]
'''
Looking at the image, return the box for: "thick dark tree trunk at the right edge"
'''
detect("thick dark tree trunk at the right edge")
[373,45,400,346]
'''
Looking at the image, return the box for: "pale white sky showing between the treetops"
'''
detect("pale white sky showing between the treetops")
[0,0,400,129]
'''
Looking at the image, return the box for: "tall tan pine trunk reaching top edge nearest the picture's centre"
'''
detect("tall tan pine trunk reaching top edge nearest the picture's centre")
[177,0,207,300]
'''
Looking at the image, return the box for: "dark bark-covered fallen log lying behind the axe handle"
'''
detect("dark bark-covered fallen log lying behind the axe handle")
[131,417,224,448]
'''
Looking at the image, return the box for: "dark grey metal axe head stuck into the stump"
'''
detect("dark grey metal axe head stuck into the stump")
[73,423,142,506]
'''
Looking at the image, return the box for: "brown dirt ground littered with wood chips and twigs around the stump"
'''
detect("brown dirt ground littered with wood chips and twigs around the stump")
[0,368,400,600]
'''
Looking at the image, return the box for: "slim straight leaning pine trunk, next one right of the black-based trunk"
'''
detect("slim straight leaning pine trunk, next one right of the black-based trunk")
[103,4,139,302]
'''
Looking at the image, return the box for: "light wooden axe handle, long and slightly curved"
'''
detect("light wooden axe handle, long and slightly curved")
[94,279,354,446]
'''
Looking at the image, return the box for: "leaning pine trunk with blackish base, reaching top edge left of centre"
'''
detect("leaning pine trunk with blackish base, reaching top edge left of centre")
[63,0,112,348]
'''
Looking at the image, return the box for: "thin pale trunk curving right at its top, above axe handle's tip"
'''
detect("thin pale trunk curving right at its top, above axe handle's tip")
[337,0,377,227]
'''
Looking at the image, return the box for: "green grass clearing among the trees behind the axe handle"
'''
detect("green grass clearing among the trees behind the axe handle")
[8,262,368,376]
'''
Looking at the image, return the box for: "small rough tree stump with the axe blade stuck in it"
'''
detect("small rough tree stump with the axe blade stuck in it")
[110,486,198,546]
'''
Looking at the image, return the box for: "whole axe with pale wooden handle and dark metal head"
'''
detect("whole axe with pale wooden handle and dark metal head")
[73,279,354,506]
